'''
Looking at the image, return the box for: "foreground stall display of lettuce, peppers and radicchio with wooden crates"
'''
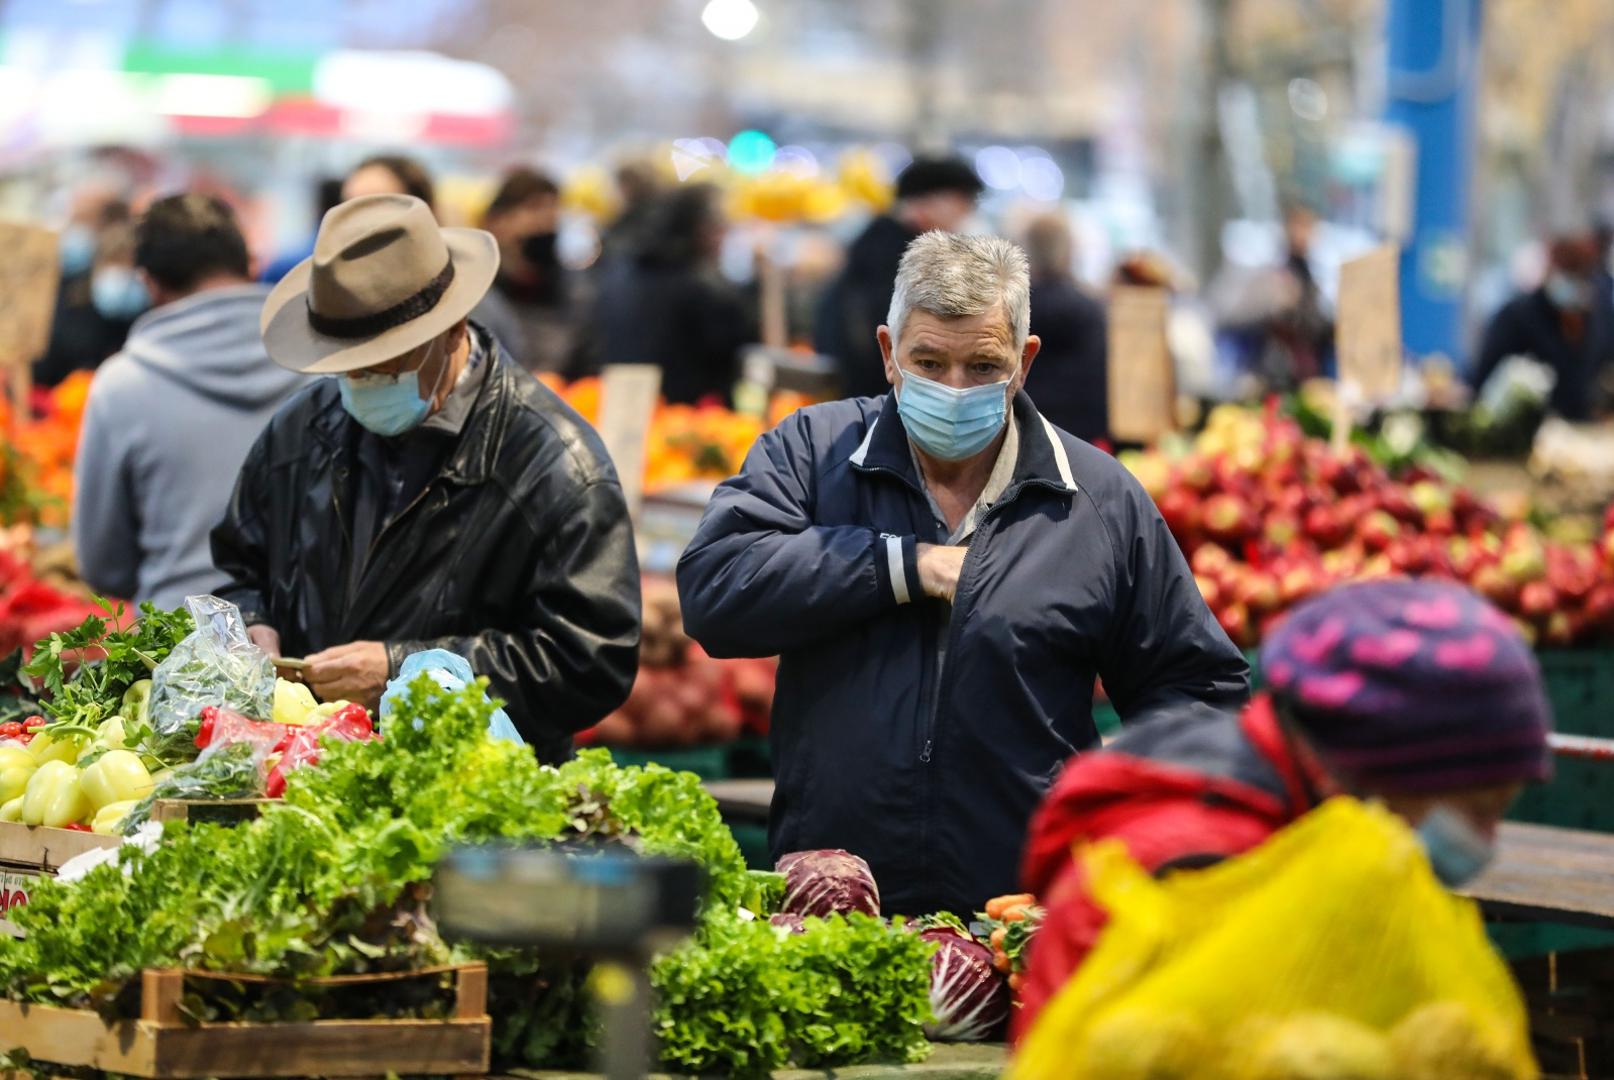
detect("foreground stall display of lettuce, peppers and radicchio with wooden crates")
[0,594,1025,1077]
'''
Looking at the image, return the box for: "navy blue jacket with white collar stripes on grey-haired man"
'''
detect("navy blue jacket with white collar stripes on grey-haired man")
[678,392,1249,914]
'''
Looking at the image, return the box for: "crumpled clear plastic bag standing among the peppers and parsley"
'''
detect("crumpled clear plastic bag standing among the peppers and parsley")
[150,596,274,736]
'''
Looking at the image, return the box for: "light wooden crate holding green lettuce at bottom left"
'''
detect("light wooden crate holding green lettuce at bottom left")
[0,964,492,1080]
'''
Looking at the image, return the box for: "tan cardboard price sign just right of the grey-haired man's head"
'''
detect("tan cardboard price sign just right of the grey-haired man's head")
[1109,286,1177,442]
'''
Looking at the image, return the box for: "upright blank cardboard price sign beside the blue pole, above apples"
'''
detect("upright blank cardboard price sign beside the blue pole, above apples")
[1335,244,1403,402]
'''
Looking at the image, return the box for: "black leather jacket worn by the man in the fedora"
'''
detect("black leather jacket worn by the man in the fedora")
[211,339,639,762]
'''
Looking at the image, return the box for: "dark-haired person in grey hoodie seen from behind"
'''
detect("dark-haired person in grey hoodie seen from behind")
[73,194,307,609]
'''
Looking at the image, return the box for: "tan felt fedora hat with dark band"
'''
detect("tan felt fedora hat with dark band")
[260,195,499,375]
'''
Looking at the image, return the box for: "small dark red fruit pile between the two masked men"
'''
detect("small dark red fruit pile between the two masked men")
[578,578,776,749]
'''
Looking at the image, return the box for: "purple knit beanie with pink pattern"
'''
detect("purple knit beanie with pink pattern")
[1261,578,1553,793]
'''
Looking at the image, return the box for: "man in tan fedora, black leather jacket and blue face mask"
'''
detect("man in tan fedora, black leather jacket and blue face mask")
[213,195,639,762]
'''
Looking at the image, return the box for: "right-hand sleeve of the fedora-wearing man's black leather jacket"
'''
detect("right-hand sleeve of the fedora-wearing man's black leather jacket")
[387,479,639,747]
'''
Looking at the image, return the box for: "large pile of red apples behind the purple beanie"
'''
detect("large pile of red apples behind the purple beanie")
[1127,401,1614,647]
